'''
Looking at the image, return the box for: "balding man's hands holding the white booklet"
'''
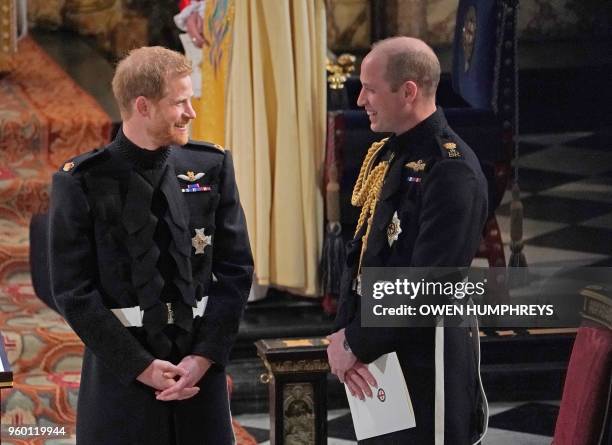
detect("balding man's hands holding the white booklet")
[327,329,378,400]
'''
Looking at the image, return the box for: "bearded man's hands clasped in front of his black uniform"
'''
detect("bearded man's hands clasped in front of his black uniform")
[136,355,212,402]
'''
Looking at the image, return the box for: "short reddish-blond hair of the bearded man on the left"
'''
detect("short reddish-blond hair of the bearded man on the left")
[113,46,192,116]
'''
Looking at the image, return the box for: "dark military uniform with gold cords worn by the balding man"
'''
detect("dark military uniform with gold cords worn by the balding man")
[336,109,487,445]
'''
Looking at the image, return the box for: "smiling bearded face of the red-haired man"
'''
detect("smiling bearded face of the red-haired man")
[147,75,196,147]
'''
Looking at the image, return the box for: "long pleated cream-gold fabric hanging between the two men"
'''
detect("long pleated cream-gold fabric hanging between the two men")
[225,0,326,295]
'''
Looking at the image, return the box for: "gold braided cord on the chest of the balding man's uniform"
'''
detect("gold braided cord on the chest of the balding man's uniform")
[351,138,390,273]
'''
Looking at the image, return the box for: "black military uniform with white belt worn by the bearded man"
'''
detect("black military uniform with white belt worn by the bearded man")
[50,130,253,445]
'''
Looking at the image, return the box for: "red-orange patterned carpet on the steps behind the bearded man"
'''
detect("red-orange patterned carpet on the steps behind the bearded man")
[0,38,111,444]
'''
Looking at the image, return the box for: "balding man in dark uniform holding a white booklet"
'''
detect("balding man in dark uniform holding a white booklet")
[328,37,487,445]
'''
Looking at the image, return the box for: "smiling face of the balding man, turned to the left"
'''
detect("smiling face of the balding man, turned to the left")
[357,53,410,133]
